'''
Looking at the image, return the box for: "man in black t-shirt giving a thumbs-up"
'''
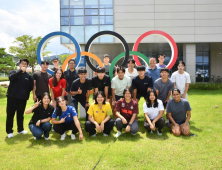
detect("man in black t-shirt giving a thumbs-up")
[70,68,92,121]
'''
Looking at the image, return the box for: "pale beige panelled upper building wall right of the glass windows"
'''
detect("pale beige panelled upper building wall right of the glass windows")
[114,0,222,43]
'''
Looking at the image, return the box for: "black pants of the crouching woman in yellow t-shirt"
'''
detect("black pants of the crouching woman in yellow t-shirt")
[85,119,115,136]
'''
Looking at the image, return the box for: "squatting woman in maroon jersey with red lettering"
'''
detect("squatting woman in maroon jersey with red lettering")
[115,88,139,137]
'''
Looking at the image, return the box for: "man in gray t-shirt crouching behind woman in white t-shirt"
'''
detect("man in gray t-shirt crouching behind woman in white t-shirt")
[154,67,174,108]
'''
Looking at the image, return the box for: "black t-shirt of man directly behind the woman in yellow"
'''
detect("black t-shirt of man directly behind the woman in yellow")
[92,75,111,92]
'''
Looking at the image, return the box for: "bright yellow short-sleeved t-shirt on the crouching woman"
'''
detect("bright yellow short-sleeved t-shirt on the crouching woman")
[87,102,113,124]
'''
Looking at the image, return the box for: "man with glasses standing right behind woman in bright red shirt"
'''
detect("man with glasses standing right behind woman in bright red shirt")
[64,59,79,105]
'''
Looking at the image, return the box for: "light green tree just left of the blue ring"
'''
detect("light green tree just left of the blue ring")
[9,35,51,73]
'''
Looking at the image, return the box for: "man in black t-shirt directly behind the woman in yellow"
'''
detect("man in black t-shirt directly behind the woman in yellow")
[92,67,111,102]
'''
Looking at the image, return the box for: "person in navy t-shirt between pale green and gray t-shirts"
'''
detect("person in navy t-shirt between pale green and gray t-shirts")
[132,65,153,103]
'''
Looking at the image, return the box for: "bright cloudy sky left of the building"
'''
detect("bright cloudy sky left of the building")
[0,0,69,55]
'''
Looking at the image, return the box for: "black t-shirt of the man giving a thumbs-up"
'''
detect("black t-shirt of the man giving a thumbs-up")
[70,78,92,100]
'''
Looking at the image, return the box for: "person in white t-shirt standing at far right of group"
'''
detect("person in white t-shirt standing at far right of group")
[171,61,191,100]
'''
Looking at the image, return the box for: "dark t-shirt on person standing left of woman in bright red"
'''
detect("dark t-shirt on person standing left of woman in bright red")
[33,71,52,96]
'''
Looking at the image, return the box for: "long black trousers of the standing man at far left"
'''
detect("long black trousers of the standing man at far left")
[6,97,27,134]
